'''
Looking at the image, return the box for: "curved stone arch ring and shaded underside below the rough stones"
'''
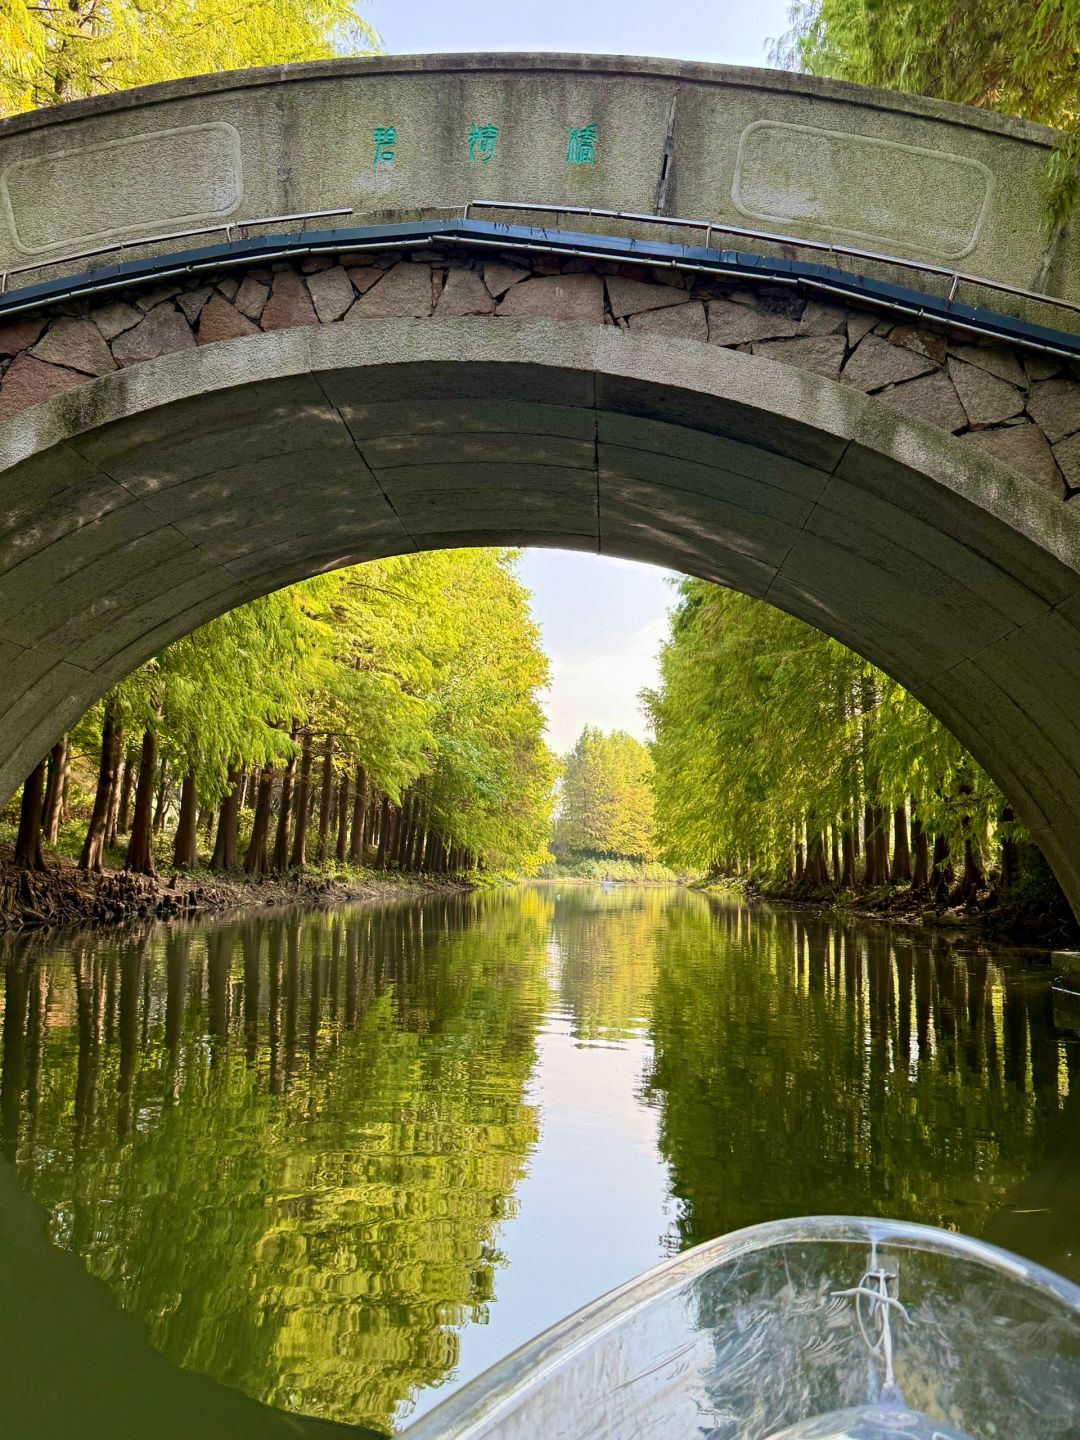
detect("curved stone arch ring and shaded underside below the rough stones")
[0,320,1080,907]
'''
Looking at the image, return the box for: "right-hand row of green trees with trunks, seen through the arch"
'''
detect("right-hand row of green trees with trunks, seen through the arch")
[645,580,1057,910]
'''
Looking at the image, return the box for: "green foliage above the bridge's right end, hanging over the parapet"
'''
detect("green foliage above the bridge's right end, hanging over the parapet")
[773,0,1080,230]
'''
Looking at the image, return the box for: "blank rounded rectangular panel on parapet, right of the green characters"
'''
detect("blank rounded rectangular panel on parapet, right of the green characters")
[732,120,994,259]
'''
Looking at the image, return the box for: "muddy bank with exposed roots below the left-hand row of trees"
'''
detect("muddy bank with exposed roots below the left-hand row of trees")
[0,858,471,933]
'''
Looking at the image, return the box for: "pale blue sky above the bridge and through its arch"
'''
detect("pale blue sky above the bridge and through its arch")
[377,0,789,752]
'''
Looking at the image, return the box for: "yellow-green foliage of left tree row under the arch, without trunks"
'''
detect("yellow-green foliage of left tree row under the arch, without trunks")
[42,550,556,876]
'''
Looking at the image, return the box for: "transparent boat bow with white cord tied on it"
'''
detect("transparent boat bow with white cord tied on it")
[406,1217,1080,1440]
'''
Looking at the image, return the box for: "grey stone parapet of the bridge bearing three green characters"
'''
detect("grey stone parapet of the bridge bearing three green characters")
[0,55,1080,316]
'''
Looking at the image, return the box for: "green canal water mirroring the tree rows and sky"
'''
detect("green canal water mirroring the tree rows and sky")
[0,886,1080,1436]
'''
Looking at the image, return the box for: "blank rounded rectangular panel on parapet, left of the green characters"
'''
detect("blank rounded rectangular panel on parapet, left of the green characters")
[0,121,243,255]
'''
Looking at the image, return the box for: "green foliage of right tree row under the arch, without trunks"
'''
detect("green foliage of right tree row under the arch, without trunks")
[645,580,1004,876]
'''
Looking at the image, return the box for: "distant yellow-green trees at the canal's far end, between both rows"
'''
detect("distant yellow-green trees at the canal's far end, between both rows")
[552,726,655,860]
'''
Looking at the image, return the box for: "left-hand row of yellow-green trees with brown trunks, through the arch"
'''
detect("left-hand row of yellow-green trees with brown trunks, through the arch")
[2,550,556,877]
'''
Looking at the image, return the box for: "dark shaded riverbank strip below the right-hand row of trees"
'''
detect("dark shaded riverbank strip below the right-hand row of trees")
[693,878,1080,950]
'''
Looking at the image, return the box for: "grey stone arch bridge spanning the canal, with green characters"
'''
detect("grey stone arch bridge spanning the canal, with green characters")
[0,56,1080,906]
